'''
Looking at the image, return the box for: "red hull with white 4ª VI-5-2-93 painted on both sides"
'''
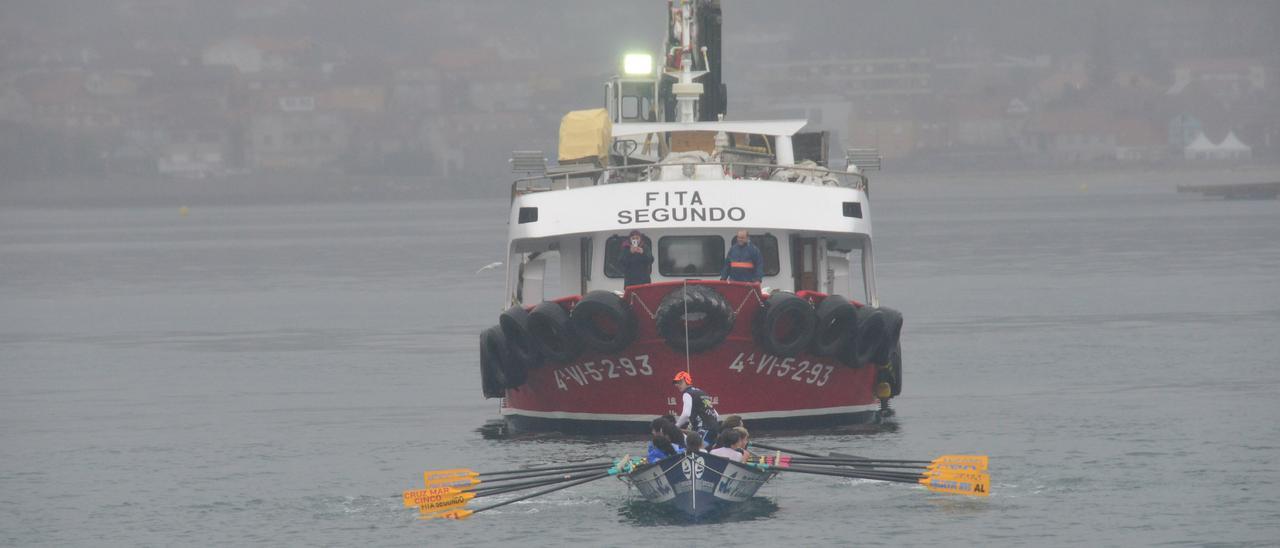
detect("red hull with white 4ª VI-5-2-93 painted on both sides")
[503,282,879,430]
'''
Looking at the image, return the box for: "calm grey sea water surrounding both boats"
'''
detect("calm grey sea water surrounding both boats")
[0,173,1280,547]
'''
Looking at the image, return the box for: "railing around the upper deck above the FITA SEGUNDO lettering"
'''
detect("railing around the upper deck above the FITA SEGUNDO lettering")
[511,161,869,197]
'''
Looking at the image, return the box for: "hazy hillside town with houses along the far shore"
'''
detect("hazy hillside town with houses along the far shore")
[0,0,1280,193]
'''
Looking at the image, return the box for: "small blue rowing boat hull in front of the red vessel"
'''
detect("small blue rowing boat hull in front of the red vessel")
[620,452,776,519]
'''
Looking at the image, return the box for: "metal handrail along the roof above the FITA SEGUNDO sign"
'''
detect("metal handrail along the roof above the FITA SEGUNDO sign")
[511,161,869,197]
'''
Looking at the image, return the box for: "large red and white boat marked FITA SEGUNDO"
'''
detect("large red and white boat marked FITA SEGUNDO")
[480,0,902,433]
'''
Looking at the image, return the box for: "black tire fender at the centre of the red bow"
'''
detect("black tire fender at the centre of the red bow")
[654,286,733,353]
